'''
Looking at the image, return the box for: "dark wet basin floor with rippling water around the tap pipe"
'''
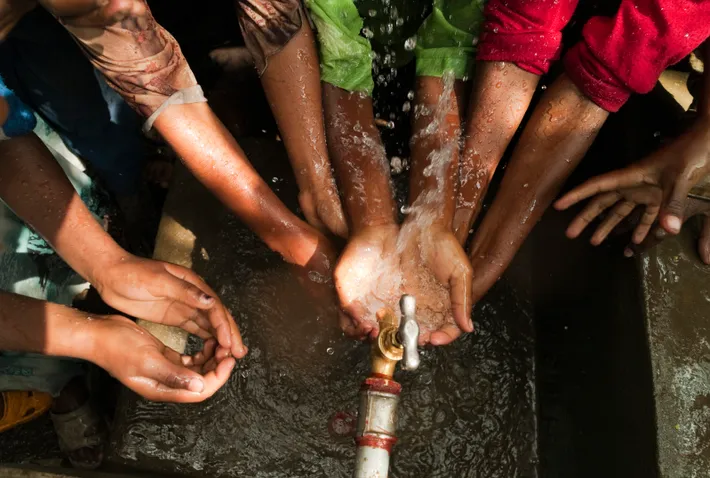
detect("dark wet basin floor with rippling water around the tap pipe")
[110,137,536,478]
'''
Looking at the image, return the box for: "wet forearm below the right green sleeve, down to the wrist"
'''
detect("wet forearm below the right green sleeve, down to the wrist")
[409,76,464,228]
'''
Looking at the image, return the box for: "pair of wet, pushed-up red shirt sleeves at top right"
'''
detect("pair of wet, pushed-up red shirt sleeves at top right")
[478,0,710,112]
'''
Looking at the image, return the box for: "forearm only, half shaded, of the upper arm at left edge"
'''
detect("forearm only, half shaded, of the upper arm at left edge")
[0,134,127,283]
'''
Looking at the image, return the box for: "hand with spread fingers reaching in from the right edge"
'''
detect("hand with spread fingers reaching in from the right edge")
[555,116,710,235]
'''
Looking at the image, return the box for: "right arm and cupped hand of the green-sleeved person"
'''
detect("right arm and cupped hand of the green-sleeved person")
[399,77,473,345]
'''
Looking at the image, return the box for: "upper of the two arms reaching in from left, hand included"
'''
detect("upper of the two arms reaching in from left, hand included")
[0,134,246,358]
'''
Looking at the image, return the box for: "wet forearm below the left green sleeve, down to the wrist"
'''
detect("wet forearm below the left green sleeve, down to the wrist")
[324,84,395,232]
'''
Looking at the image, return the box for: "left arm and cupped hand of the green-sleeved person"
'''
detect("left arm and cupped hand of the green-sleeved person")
[323,83,400,337]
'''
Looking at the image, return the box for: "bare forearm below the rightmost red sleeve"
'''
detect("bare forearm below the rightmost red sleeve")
[470,75,608,300]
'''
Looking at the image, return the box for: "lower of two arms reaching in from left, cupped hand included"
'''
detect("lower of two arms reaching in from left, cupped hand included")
[0,291,235,403]
